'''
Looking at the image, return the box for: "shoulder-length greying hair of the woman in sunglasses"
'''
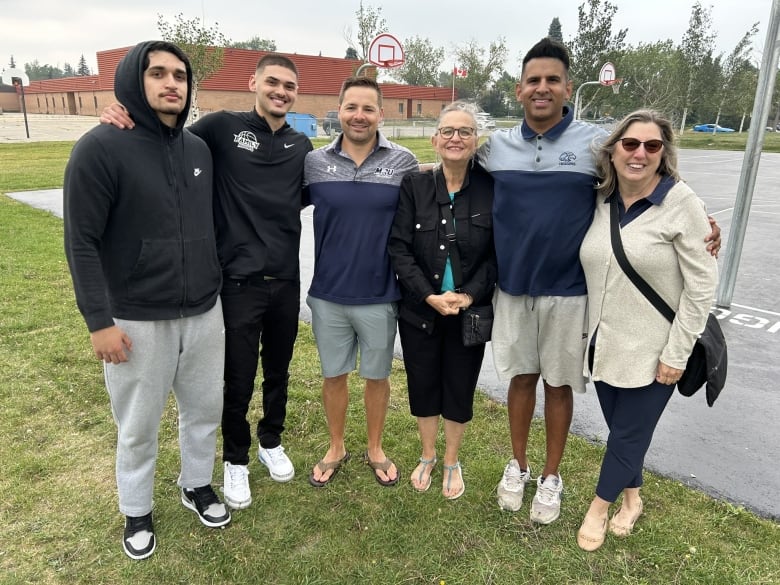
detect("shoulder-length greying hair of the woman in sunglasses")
[595,110,681,195]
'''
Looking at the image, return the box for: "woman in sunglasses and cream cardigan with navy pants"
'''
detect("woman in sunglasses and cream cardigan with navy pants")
[577,110,717,551]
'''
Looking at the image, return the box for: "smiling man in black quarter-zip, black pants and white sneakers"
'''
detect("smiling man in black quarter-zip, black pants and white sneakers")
[100,53,312,509]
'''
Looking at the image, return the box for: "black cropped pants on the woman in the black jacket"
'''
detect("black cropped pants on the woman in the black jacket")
[398,313,485,423]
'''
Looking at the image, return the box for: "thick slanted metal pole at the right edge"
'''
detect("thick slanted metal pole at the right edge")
[715,0,780,308]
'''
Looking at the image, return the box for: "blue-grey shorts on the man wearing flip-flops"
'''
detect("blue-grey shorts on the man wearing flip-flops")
[306,296,398,380]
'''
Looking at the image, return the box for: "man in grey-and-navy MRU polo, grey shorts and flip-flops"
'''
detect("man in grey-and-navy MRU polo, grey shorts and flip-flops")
[304,77,418,487]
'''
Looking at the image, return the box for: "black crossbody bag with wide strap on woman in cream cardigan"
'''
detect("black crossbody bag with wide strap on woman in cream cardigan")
[609,194,728,406]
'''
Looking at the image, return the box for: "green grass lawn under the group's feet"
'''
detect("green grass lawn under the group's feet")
[0,143,780,585]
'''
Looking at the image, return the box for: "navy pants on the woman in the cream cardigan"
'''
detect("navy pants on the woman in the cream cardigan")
[595,382,674,502]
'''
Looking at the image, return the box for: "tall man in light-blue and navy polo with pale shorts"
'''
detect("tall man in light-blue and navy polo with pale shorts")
[478,38,720,524]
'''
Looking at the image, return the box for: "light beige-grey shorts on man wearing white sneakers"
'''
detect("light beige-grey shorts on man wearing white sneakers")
[491,290,588,392]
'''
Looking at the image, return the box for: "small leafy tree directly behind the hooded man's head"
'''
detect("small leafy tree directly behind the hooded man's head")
[157,13,229,117]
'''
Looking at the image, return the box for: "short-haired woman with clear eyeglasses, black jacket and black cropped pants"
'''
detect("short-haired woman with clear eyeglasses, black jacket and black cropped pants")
[388,102,496,500]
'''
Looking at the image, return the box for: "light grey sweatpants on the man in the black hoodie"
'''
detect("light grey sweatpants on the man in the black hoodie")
[104,299,225,516]
